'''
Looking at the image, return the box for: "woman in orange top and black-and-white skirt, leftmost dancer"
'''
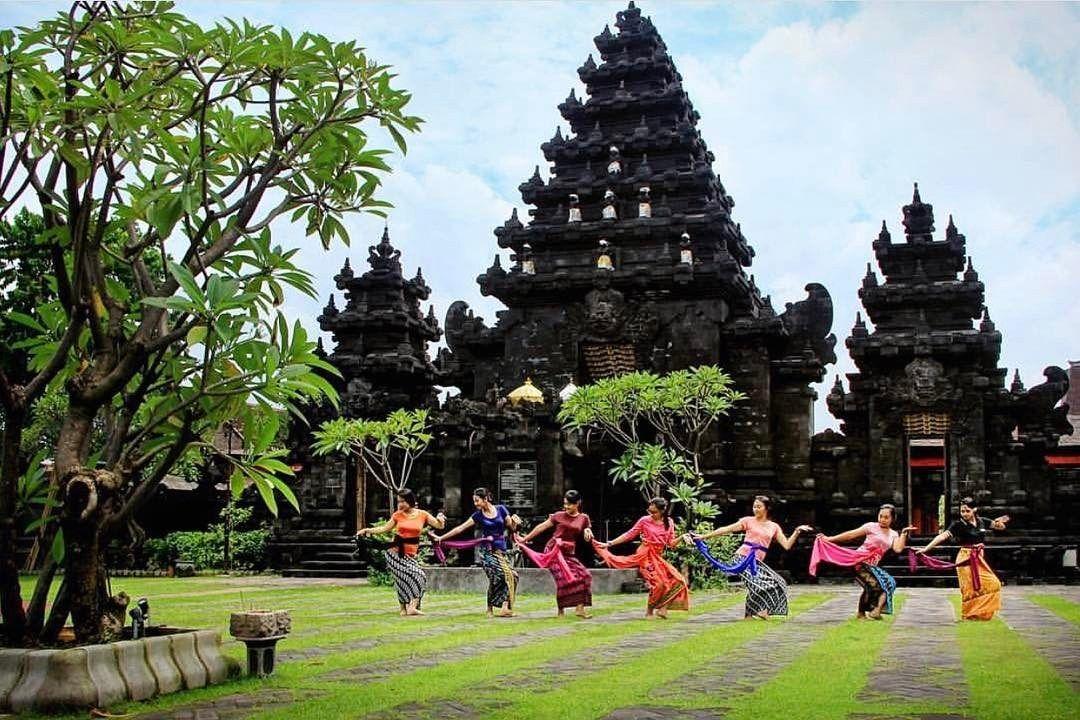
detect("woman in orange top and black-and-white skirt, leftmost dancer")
[356,490,446,615]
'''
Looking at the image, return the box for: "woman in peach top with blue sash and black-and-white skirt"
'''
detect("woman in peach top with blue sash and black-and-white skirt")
[690,495,813,620]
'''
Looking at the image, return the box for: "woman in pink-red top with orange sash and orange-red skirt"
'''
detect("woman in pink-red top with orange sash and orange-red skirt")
[593,498,690,620]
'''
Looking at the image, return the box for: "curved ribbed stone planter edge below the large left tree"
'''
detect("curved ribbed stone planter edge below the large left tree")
[0,627,239,712]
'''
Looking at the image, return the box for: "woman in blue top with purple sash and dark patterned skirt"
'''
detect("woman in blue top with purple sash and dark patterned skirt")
[435,488,522,617]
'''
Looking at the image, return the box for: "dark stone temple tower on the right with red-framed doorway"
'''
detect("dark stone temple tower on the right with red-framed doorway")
[814,185,1070,544]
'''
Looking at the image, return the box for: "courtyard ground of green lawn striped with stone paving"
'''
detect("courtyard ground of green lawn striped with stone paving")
[12,576,1080,720]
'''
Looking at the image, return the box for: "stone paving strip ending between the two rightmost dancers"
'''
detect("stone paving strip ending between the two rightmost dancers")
[859,587,968,706]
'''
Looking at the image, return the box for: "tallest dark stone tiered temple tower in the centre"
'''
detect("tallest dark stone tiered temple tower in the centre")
[436,3,835,514]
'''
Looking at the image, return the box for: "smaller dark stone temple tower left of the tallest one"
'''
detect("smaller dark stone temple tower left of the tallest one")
[273,230,442,576]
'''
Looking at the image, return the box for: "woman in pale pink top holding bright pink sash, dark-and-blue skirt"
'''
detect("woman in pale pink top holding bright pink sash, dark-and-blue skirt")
[810,503,916,620]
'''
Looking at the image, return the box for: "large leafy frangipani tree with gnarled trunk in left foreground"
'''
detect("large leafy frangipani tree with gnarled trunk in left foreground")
[0,2,420,643]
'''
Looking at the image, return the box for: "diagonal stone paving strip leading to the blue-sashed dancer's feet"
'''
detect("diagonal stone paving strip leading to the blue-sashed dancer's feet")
[366,603,743,720]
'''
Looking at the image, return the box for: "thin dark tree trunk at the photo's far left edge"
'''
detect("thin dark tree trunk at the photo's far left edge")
[0,410,26,646]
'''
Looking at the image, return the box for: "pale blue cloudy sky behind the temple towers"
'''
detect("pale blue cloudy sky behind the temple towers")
[0,1,1080,430]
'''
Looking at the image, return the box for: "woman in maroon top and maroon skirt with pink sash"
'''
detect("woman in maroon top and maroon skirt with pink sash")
[518,490,593,619]
